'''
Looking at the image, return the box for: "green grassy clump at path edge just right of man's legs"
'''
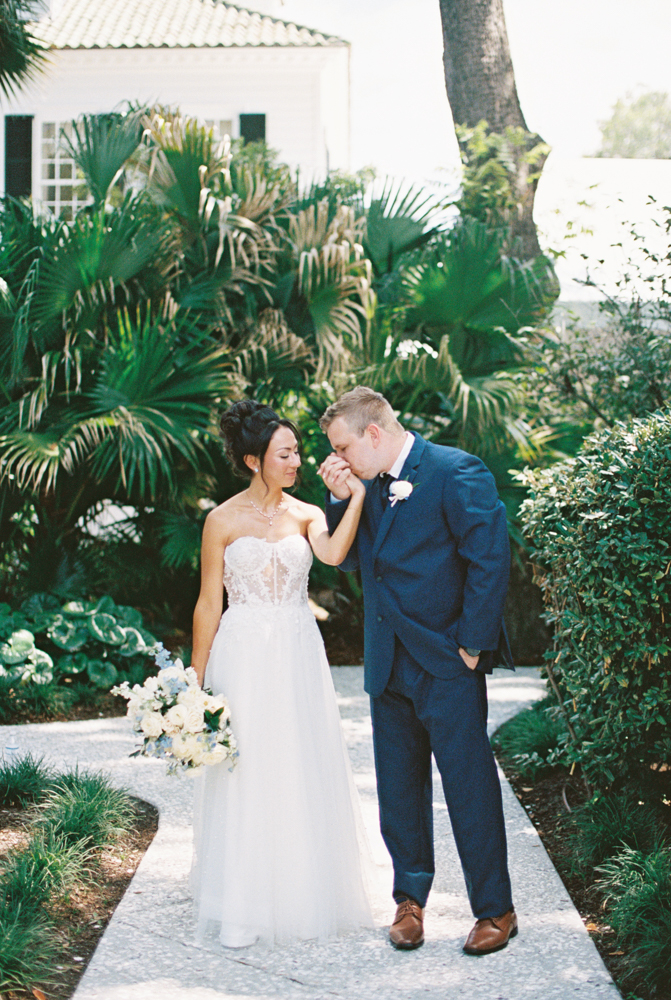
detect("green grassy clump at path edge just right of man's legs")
[492,698,566,779]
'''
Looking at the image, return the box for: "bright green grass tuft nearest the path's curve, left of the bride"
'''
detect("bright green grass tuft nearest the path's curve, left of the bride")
[38,768,135,848]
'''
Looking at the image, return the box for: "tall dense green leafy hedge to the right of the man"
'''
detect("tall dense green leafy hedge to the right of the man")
[521,411,671,787]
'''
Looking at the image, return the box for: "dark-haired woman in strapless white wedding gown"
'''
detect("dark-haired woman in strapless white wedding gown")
[191,400,372,948]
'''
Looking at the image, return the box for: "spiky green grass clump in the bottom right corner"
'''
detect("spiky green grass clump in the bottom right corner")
[597,847,671,989]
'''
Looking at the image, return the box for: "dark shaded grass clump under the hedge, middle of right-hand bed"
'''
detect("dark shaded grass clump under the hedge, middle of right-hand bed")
[572,791,661,869]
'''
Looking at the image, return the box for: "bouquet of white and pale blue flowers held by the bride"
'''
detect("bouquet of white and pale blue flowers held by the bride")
[112,642,238,774]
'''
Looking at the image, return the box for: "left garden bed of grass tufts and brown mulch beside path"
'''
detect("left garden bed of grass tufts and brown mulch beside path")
[0,756,157,1000]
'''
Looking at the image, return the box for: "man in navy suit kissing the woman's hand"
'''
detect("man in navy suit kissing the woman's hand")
[320,386,517,955]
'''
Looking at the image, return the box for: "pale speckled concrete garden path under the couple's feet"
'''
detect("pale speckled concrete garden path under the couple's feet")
[0,667,619,1000]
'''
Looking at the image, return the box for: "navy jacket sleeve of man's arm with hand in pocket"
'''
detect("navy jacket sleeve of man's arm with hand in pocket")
[443,452,510,650]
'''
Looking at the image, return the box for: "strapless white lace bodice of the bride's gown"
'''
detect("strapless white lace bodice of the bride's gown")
[224,535,312,606]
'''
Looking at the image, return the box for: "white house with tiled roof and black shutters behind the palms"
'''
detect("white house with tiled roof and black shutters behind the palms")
[0,0,350,216]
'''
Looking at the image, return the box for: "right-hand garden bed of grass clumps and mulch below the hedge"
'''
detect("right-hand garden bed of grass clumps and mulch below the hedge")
[492,712,671,1000]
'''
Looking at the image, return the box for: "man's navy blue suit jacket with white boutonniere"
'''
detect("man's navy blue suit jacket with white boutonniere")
[326,434,512,698]
